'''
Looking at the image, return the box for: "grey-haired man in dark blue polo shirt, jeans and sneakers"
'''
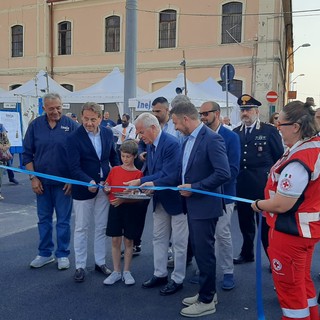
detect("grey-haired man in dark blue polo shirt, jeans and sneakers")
[23,93,78,270]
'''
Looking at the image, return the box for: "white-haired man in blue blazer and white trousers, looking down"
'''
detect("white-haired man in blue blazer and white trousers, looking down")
[128,113,189,295]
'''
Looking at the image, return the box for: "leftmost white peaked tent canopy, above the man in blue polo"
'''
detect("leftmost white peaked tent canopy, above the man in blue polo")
[0,70,70,103]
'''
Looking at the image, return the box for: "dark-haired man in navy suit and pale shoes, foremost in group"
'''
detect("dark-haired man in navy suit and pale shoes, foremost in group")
[171,102,230,317]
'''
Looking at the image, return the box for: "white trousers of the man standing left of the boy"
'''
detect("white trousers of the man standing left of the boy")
[73,189,109,269]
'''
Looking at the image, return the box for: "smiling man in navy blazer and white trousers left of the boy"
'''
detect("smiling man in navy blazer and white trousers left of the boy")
[67,102,120,282]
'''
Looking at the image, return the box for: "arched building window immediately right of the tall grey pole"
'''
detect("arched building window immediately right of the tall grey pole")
[159,10,177,49]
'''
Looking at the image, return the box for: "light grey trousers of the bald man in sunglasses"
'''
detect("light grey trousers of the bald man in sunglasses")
[215,203,234,274]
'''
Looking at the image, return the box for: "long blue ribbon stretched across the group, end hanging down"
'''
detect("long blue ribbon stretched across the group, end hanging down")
[0,165,265,320]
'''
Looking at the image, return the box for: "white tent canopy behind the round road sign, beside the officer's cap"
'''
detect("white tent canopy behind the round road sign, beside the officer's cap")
[197,77,240,125]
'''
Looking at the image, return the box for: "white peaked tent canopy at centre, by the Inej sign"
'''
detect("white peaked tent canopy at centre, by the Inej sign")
[129,73,216,111]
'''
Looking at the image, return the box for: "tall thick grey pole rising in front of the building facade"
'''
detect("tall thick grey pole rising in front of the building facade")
[123,0,138,114]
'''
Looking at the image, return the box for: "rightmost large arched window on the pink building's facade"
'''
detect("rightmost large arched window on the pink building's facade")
[221,2,242,44]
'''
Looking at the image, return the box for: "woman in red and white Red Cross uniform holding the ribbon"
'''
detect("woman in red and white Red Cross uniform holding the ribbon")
[252,101,320,320]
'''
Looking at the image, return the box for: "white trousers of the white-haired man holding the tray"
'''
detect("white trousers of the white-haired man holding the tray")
[153,203,189,283]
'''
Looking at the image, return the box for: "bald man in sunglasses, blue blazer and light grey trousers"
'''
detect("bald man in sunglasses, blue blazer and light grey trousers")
[199,101,240,290]
